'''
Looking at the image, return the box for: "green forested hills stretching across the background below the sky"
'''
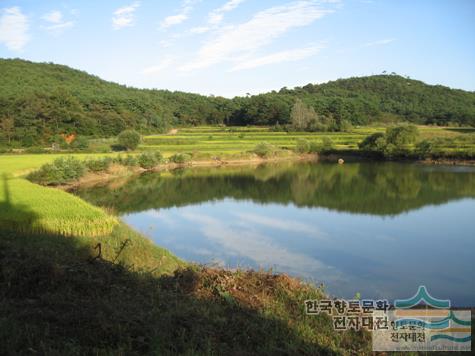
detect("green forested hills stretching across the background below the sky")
[0,59,475,145]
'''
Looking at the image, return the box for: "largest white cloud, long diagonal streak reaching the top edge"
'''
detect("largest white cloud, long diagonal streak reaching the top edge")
[181,0,333,71]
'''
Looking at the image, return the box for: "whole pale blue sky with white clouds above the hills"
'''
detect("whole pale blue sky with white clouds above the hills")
[0,0,475,97]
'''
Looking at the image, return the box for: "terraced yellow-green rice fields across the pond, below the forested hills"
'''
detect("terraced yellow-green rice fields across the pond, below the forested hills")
[139,126,475,157]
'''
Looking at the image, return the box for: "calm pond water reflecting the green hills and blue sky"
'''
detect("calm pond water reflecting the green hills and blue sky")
[75,162,475,306]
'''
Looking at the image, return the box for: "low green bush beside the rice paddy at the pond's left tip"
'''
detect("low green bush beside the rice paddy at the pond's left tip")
[28,157,86,185]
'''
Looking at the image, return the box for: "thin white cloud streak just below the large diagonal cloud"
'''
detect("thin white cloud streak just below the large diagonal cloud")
[231,46,323,71]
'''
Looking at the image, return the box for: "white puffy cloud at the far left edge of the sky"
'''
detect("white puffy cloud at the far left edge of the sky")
[0,7,30,51]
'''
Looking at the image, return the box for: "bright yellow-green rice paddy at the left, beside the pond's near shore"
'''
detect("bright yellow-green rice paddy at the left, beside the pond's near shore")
[0,154,117,236]
